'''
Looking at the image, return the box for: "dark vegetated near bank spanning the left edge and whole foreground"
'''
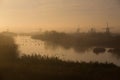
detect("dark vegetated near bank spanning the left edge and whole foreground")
[0,34,120,80]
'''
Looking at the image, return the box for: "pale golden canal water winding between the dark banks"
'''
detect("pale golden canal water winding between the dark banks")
[15,36,120,66]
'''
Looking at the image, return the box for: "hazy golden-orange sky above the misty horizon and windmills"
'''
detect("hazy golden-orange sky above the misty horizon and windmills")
[0,0,120,32]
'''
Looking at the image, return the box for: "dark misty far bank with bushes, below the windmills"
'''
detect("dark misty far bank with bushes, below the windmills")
[32,31,120,48]
